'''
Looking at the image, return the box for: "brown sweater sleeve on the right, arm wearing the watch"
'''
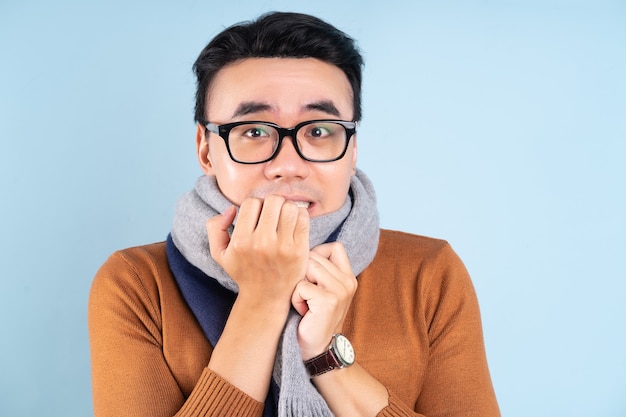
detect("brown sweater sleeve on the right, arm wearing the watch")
[378,239,500,417]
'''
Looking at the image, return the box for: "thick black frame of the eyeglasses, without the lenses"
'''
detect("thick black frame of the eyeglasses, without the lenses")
[200,119,358,165]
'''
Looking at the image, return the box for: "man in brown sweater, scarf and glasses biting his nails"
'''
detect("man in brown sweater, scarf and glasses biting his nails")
[89,13,499,417]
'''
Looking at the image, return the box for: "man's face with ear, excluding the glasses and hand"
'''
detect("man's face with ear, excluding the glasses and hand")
[196,58,356,217]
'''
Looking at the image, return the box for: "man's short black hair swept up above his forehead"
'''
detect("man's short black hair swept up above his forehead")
[193,12,363,122]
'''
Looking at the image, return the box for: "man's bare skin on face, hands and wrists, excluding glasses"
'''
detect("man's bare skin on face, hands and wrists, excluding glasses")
[196,58,388,416]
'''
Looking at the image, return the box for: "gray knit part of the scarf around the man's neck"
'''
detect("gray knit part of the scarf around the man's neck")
[171,169,379,417]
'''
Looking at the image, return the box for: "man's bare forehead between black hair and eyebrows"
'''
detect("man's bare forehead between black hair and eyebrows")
[207,58,353,121]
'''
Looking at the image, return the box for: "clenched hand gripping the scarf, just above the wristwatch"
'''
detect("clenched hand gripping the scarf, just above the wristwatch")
[291,242,357,360]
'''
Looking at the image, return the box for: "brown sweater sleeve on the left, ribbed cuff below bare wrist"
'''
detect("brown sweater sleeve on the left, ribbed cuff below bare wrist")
[88,251,263,417]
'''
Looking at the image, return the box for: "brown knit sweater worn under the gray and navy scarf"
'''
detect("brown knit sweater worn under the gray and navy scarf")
[89,230,500,417]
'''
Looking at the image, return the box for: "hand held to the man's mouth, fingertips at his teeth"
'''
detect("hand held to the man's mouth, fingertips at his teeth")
[207,195,310,310]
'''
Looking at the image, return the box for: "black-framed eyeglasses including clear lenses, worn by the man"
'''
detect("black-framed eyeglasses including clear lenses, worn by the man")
[202,120,357,164]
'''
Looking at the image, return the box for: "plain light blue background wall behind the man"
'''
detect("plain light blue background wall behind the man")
[0,0,626,417]
